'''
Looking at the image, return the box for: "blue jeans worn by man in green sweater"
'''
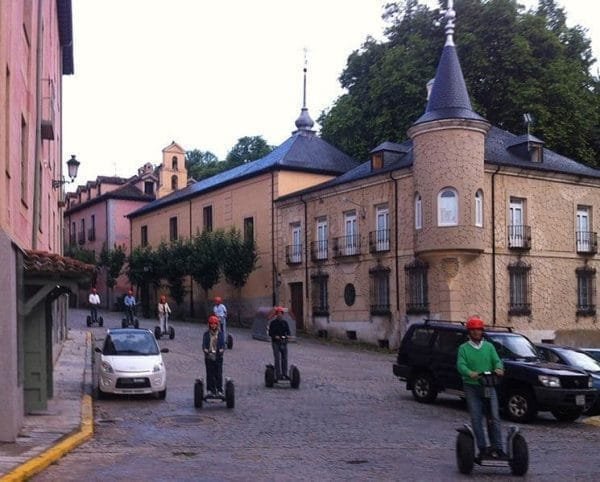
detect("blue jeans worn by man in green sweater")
[463,383,503,452]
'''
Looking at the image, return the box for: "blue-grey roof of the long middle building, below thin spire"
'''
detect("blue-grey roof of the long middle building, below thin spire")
[128,132,357,218]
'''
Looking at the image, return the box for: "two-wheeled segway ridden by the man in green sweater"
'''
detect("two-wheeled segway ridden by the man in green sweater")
[456,372,529,476]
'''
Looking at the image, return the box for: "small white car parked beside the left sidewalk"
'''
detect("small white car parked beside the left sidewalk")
[95,328,169,399]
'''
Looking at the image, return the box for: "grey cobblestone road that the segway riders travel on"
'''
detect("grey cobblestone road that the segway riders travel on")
[34,311,600,481]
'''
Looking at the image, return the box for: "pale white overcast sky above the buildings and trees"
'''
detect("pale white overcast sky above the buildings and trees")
[63,0,600,190]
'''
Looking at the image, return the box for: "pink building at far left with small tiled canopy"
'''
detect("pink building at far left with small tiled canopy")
[0,0,89,442]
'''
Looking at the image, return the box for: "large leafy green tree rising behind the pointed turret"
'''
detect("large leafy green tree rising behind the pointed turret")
[319,0,600,165]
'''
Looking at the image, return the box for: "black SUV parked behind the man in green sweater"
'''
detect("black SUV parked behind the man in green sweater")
[394,320,596,422]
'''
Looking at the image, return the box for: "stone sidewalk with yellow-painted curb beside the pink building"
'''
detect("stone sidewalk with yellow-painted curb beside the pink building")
[0,329,93,482]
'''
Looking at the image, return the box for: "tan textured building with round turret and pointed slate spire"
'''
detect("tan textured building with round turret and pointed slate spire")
[275,2,600,346]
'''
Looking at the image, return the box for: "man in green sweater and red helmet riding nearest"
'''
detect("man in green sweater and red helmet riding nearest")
[456,316,506,458]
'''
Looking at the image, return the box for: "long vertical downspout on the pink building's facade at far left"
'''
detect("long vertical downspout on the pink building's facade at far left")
[31,0,43,249]
